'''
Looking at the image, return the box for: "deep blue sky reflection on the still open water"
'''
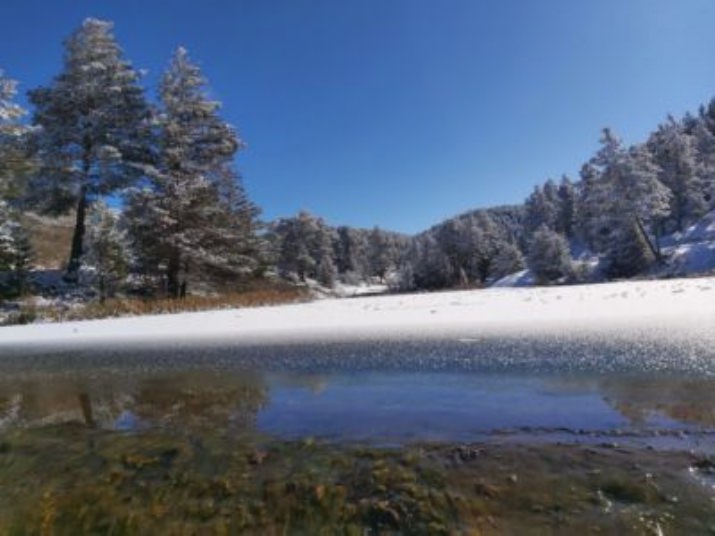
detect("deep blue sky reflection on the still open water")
[258,373,688,440]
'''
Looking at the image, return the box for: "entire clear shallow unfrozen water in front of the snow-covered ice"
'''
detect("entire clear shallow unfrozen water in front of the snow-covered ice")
[0,345,715,534]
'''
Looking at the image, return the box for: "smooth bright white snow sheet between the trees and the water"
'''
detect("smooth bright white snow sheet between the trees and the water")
[0,278,715,348]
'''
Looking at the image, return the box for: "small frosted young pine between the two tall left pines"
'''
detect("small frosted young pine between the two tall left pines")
[82,202,129,303]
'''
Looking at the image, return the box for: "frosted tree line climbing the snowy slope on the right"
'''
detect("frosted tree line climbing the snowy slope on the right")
[400,114,715,289]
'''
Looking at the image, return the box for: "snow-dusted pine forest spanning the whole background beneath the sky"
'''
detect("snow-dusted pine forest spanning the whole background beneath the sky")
[0,19,715,314]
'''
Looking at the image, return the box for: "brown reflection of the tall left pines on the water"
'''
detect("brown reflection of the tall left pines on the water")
[0,371,268,432]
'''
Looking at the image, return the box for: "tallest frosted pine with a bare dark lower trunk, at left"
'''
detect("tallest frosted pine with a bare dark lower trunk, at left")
[29,19,150,280]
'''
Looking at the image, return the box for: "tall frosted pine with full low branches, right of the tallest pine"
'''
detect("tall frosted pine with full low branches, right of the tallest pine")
[126,48,258,297]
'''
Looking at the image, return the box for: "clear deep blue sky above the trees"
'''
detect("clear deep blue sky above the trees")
[0,0,715,232]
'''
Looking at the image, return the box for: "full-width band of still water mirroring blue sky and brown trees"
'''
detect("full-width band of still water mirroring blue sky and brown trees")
[0,369,715,441]
